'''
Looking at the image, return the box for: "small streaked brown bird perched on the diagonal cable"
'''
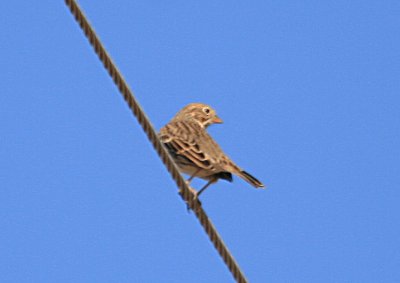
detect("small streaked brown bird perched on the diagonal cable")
[159,103,264,197]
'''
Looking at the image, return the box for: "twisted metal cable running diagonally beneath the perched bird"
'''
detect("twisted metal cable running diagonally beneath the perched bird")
[65,0,247,283]
